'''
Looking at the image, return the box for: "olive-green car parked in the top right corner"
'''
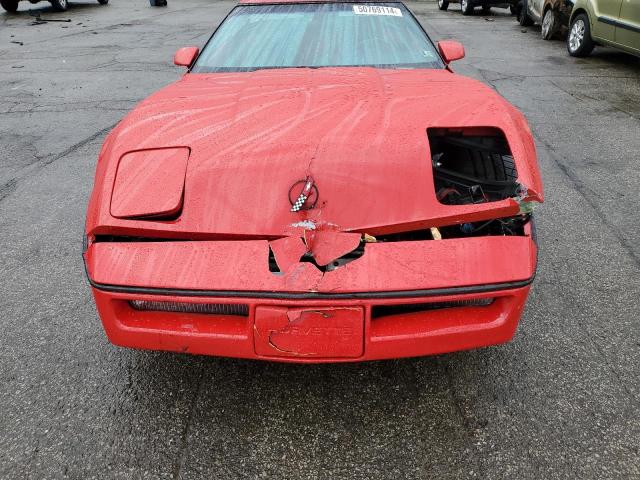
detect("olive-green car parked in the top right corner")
[567,0,640,57]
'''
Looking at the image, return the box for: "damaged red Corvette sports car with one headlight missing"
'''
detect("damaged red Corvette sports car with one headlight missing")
[84,0,543,362]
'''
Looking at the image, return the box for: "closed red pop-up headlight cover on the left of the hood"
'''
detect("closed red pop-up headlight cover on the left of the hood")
[111,148,189,218]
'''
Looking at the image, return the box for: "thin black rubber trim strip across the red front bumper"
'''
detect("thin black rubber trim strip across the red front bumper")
[87,275,535,300]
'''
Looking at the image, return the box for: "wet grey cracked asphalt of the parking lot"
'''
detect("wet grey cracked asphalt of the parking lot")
[0,0,640,479]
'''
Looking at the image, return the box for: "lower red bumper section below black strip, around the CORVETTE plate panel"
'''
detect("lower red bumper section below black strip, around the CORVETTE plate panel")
[93,287,529,363]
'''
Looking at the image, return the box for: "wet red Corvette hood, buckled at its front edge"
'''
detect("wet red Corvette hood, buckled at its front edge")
[87,68,542,236]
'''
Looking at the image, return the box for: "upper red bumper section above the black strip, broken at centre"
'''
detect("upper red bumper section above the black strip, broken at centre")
[86,237,536,293]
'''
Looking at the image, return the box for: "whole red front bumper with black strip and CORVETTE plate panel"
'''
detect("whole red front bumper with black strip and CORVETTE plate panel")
[84,225,537,362]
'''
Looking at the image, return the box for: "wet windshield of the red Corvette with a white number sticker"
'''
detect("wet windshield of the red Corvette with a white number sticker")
[191,3,444,73]
